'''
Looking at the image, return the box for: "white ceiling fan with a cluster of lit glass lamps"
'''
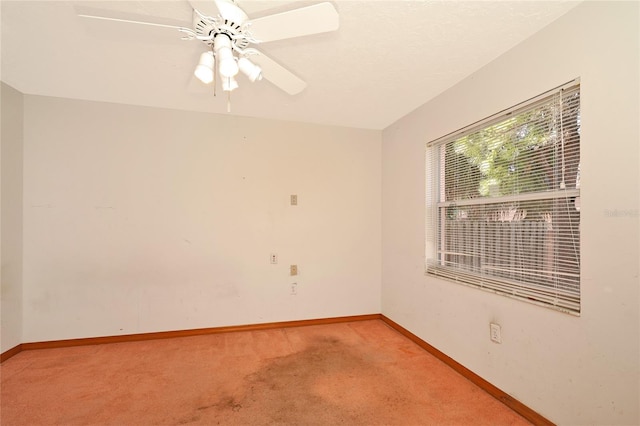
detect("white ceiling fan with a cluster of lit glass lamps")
[78,0,339,103]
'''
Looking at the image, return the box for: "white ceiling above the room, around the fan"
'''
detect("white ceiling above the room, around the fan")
[0,0,578,129]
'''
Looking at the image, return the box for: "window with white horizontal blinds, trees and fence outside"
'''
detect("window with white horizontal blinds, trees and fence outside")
[426,81,580,314]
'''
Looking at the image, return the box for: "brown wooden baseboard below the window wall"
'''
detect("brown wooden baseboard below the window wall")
[380,315,554,426]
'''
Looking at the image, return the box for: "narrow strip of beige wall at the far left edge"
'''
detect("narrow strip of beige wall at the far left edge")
[0,83,23,352]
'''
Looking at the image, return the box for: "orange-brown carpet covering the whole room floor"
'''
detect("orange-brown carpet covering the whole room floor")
[0,320,530,426]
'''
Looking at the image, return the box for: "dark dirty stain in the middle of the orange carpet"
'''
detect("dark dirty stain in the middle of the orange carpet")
[191,337,404,425]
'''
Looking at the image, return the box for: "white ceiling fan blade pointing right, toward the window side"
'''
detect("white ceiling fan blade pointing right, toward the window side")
[249,2,340,43]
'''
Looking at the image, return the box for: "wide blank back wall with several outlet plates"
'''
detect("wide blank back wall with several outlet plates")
[24,95,381,342]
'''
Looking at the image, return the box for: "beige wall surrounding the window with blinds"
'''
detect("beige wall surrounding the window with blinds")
[382,1,640,425]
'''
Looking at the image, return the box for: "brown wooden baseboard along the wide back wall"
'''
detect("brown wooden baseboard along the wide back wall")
[2,314,381,356]
